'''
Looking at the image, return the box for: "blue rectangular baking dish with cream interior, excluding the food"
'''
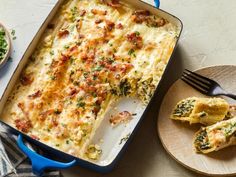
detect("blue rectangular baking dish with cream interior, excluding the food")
[0,0,182,175]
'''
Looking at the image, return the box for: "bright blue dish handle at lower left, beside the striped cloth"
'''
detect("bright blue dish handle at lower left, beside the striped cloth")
[17,134,76,176]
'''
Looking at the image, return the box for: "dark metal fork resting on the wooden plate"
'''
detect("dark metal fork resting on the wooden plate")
[181,69,236,100]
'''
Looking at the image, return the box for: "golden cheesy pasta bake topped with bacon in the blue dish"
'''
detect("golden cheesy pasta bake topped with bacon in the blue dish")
[1,0,179,160]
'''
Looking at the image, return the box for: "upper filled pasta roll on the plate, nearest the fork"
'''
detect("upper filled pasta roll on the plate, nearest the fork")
[171,97,229,125]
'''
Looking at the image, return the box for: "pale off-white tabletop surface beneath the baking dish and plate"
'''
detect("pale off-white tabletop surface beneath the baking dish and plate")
[0,0,236,177]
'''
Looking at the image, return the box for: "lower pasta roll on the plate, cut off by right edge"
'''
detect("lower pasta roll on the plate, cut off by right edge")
[194,117,236,154]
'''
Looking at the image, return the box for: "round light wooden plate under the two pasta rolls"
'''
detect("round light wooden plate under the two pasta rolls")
[157,66,236,176]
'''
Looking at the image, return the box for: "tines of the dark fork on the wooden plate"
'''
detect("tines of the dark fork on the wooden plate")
[181,69,212,94]
